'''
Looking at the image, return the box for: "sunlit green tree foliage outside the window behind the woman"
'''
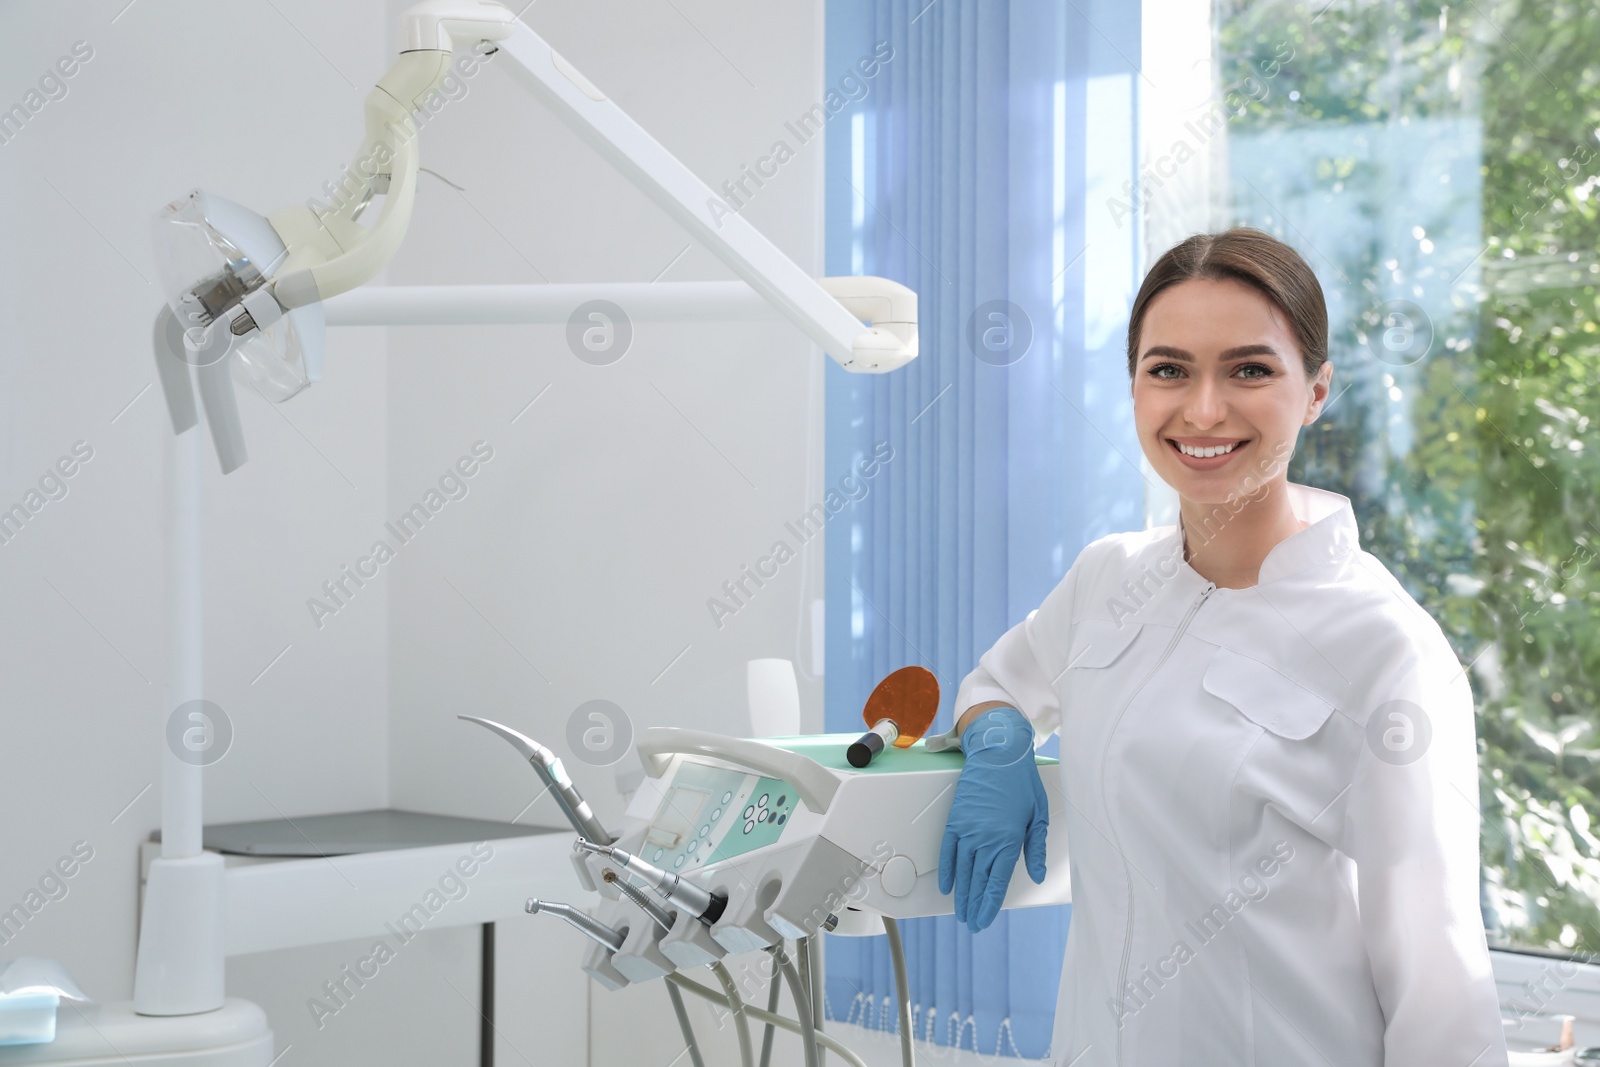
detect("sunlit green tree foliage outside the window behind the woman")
[1218,0,1600,953]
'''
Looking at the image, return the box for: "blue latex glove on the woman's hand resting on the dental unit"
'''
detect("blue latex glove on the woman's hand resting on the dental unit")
[939,707,1050,934]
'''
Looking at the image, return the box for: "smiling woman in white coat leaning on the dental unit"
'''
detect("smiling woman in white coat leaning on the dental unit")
[939,229,1507,1067]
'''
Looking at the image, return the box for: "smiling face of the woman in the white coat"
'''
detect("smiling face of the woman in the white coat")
[1133,278,1333,504]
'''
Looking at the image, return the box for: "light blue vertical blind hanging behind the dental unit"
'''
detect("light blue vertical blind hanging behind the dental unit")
[826,0,1144,1057]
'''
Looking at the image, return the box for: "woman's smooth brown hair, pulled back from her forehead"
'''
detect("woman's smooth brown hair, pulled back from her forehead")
[1128,226,1328,378]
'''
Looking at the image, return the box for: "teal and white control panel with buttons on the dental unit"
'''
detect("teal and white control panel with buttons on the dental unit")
[640,760,798,873]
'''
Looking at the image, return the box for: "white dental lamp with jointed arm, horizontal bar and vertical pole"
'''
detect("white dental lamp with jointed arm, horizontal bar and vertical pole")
[133,0,917,1062]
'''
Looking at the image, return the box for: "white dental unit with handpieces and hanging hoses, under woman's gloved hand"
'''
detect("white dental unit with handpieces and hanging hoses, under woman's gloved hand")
[462,717,1070,1067]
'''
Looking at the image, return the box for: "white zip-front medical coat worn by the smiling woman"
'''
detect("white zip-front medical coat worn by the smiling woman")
[957,483,1506,1067]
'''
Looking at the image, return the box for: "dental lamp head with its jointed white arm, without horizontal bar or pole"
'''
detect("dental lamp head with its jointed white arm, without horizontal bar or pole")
[155,0,917,474]
